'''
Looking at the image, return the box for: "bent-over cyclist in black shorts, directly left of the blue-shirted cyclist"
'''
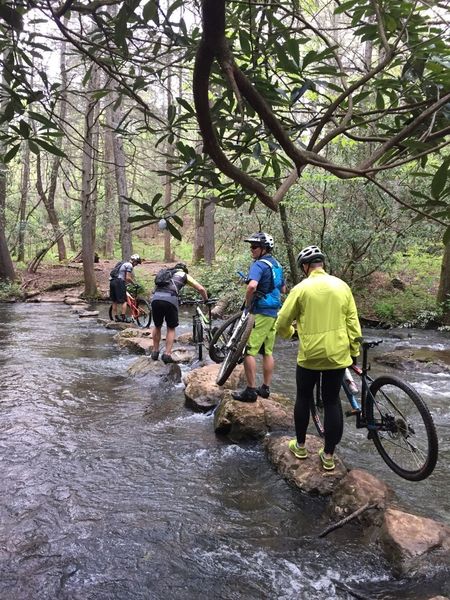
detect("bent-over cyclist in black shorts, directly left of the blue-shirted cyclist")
[151,263,208,364]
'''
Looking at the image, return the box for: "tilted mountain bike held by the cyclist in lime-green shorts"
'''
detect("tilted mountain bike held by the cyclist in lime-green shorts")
[212,308,255,385]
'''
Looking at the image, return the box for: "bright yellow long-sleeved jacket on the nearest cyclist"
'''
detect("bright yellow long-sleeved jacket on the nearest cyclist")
[276,269,361,371]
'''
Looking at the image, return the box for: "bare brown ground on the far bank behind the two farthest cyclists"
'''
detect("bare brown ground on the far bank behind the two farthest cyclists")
[16,259,167,302]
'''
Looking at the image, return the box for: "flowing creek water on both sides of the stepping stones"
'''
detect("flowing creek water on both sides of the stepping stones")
[0,304,450,600]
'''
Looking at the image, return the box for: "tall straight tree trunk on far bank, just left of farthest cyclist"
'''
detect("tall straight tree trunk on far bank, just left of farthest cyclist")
[81,68,98,298]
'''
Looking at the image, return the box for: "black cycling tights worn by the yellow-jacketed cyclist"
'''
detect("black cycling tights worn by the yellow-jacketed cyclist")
[294,365,345,454]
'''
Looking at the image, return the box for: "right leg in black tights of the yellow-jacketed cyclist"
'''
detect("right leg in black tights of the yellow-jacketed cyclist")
[322,369,345,458]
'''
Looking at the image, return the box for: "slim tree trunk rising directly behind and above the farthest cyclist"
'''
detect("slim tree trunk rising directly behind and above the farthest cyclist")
[102,105,116,258]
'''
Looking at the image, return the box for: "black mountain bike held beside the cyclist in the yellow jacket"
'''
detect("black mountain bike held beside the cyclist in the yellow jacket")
[311,340,438,481]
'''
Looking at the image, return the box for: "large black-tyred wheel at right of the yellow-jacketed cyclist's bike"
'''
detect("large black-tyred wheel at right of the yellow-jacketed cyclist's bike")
[367,376,438,481]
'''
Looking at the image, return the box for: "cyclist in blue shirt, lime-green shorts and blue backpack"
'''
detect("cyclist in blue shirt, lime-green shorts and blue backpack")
[232,231,286,402]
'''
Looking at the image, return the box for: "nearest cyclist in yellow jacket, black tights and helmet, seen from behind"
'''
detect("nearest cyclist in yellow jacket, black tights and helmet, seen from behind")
[276,246,361,471]
